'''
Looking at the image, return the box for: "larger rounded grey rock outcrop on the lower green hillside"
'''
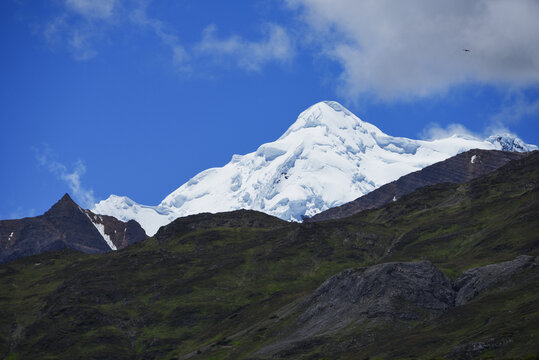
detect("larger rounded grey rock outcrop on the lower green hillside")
[292,261,455,336]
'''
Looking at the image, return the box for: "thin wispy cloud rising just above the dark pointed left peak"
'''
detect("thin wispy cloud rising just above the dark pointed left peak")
[33,145,95,208]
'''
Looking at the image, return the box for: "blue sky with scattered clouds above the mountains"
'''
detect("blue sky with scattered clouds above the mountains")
[0,0,539,219]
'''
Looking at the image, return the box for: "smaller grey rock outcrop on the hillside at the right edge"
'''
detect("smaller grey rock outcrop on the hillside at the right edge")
[454,255,538,306]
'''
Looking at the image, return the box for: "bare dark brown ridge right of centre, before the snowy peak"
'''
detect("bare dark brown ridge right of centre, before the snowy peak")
[304,149,529,222]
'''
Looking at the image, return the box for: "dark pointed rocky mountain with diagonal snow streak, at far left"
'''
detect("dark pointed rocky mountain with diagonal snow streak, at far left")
[0,194,146,263]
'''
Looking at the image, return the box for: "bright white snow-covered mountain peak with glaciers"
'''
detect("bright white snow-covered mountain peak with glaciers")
[91,101,537,236]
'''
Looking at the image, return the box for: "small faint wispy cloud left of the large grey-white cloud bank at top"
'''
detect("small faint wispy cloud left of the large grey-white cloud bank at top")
[195,24,294,71]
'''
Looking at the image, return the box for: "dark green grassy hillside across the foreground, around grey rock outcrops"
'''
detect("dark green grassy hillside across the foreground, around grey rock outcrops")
[0,153,539,359]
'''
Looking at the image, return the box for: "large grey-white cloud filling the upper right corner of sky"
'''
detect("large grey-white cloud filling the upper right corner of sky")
[287,0,539,100]
